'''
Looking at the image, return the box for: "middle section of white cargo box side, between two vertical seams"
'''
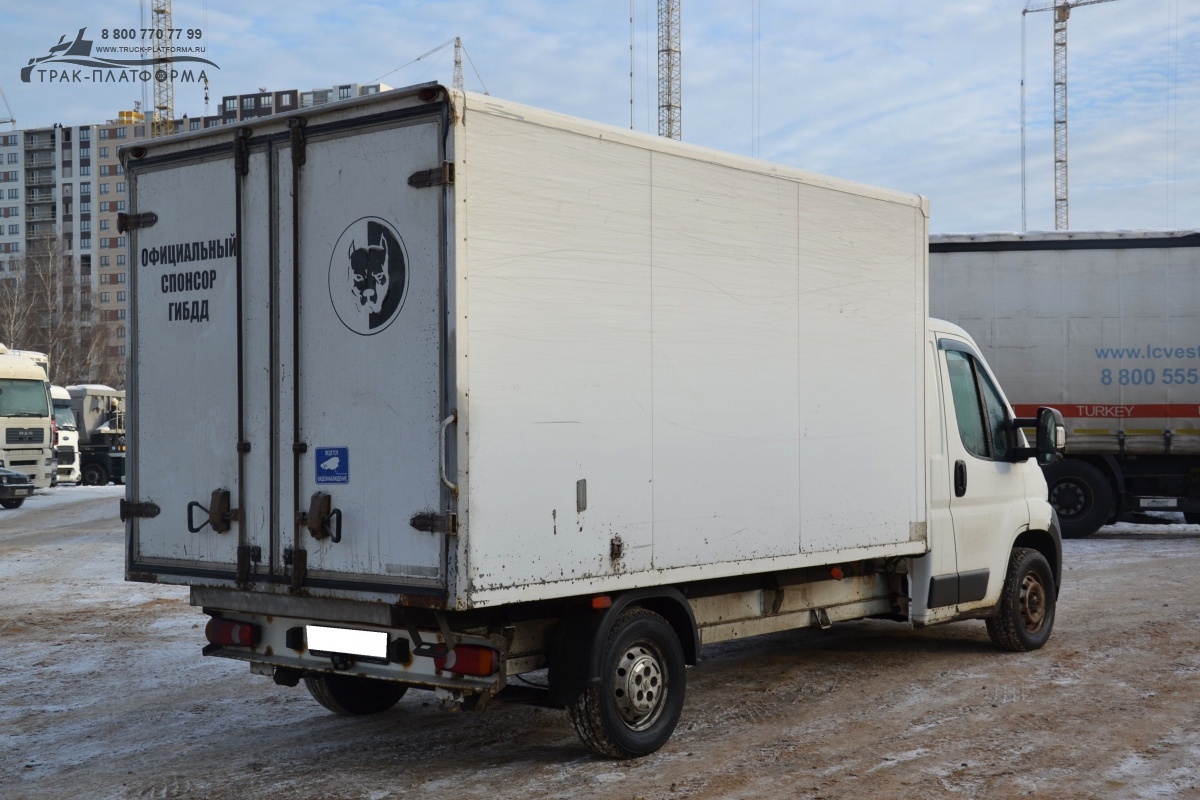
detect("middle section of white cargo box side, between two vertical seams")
[653,154,800,569]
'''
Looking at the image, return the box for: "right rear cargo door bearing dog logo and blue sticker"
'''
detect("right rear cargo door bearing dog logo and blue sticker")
[278,109,446,589]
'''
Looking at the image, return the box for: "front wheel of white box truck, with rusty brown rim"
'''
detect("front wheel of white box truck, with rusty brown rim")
[988,547,1058,652]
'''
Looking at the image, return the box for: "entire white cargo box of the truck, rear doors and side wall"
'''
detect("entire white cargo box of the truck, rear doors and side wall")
[126,89,928,609]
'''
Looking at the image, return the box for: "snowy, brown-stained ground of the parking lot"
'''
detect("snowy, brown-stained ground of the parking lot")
[0,486,1200,800]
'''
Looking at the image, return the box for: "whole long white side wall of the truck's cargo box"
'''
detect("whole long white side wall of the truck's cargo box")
[456,108,925,603]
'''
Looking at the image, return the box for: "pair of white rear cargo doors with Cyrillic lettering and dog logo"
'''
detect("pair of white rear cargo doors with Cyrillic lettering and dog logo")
[128,102,452,594]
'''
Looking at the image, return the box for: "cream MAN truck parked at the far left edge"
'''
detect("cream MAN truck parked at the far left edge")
[0,344,55,489]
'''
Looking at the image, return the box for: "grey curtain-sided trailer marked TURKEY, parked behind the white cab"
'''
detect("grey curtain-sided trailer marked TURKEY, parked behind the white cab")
[929,230,1200,536]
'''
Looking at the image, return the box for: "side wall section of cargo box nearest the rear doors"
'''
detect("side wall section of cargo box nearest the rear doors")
[460,114,652,590]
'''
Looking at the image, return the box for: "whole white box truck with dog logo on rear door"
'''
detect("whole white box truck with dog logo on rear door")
[121,85,1062,757]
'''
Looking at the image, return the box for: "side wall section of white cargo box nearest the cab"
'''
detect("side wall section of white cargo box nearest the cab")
[799,187,925,552]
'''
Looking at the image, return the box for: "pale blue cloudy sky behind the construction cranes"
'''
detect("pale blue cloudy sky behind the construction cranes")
[0,0,1200,233]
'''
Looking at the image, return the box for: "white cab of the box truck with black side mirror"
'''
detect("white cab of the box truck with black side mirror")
[912,319,1064,644]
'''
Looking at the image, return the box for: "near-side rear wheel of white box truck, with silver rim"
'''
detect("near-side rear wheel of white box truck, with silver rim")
[566,608,686,758]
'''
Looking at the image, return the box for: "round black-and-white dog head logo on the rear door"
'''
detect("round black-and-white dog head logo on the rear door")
[329,217,408,336]
